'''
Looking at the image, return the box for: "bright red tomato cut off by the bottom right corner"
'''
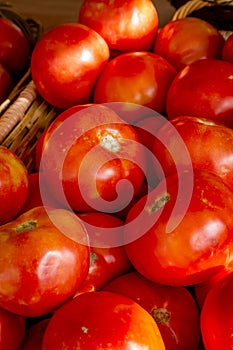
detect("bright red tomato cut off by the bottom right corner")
[200,273,233,350]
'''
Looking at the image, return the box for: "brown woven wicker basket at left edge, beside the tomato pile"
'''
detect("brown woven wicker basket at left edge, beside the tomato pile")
[0,3,58,172]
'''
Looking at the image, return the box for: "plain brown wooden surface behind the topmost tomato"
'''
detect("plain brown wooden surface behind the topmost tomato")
[6,0,174,31]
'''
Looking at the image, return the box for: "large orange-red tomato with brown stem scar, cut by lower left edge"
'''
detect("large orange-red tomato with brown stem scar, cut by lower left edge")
[0,207,89,316]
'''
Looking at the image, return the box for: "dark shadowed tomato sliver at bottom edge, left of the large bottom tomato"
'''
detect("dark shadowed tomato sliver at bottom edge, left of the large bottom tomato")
[17,318,50,350]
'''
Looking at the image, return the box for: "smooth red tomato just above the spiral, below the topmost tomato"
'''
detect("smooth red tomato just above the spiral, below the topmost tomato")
[94,52,176,114]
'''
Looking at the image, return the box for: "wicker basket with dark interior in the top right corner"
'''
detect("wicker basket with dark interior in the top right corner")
[172,0,233,39]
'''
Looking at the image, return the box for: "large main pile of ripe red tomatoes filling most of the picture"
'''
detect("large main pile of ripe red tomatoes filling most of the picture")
[0,0,233,350]
